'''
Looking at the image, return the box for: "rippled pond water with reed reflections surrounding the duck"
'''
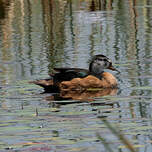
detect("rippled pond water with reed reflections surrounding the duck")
[0,0,152,152]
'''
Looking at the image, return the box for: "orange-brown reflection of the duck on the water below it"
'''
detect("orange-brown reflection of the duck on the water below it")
[47,88,118,102]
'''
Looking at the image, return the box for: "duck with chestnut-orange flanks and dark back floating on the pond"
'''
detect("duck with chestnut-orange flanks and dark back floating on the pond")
[30,54,119,93]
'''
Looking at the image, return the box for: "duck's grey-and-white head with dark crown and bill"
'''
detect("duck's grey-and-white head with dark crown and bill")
[89,54,118,78]
